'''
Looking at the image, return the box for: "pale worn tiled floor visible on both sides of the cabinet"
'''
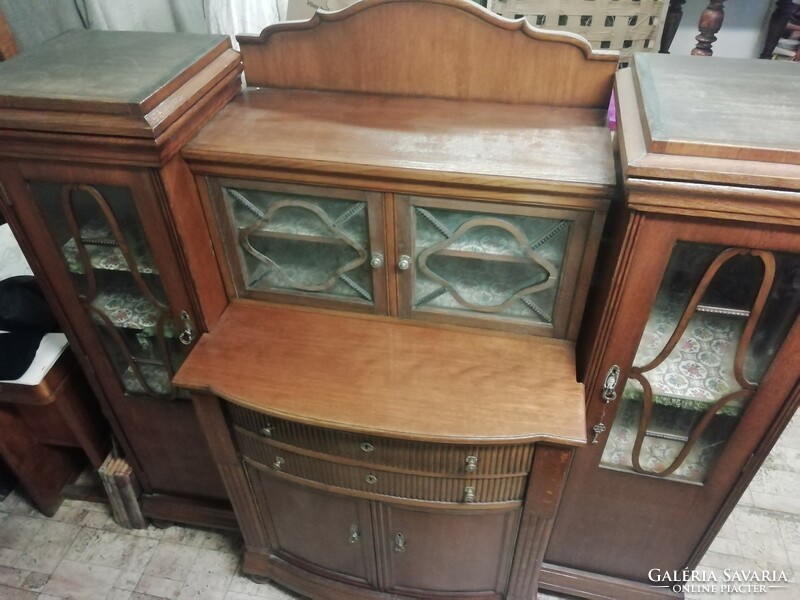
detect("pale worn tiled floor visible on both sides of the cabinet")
[0,416,800,600]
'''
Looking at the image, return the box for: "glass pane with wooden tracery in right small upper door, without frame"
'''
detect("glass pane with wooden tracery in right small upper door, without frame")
[412,206,571,325]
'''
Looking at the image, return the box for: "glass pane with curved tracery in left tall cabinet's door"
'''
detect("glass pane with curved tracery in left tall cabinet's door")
[29,182,186,397]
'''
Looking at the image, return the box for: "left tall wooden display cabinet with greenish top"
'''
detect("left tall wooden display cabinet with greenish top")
[0,31,241,526]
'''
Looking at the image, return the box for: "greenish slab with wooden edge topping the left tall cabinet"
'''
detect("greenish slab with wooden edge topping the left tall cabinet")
[0,30,228,115]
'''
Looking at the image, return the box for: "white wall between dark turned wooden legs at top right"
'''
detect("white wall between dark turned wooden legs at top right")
[670,0,774,58]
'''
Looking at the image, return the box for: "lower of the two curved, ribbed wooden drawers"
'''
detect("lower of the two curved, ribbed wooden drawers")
[236,434,527,503]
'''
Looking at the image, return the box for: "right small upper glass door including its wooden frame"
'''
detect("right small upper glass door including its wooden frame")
[398,196,587,337]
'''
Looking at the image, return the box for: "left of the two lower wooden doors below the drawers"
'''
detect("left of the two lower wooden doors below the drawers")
[248,468,377,587]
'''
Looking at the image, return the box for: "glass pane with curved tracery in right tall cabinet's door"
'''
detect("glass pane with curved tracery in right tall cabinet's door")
[601,242,800,483]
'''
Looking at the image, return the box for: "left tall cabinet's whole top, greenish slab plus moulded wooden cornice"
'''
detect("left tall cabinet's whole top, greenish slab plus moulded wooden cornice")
[0,30,242,165]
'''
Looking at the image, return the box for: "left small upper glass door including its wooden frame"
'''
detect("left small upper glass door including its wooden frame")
[211,180,385,312]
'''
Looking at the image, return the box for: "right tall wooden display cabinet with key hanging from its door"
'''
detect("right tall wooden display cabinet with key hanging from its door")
[542,55,800,598]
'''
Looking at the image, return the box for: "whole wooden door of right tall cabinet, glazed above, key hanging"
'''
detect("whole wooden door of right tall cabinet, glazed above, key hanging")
[545,218,800,583]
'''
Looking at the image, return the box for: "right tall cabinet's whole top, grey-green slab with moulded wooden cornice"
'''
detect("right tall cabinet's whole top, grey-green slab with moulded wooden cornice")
[616,54,800,212]
